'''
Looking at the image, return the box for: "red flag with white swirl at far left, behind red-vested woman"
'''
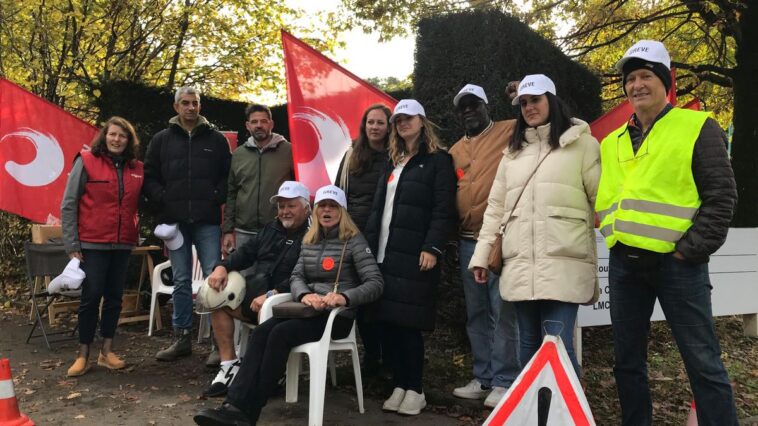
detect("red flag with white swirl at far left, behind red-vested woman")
[0,78,97,223]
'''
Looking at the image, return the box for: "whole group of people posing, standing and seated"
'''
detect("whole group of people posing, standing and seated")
[62,40,737,425]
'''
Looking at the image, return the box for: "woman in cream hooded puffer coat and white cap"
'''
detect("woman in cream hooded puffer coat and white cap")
[469,74,600,375]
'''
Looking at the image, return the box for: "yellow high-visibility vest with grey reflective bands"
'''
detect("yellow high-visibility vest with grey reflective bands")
[595,108,710,253]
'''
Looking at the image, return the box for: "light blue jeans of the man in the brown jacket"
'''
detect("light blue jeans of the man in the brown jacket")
[458,239,523,388]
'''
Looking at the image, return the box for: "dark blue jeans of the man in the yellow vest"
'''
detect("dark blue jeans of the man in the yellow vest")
[609,248,737,425]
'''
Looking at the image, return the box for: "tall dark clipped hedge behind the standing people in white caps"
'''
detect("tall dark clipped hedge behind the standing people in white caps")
[413,10,602,144]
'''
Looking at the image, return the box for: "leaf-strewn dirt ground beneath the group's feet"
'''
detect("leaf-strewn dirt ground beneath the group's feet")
[0,305,758,426]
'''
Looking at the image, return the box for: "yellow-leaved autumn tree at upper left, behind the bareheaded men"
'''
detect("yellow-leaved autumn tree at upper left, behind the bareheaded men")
[0,0,344,117]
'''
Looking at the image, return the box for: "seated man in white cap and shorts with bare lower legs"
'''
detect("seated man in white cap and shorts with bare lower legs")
[203,181,310,397]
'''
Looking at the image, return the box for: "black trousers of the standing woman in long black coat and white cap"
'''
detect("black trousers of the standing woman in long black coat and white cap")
[384,324,424,393]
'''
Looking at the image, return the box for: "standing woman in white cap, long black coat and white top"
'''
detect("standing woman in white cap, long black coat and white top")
[366,99,457,415]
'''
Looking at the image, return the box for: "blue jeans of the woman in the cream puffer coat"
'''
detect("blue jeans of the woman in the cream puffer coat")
[514,300,582,377]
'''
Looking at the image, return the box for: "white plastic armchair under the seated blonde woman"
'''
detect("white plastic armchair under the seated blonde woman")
[260,293,365,426]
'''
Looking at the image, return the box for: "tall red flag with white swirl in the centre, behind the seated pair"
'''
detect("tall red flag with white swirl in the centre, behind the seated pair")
[282,31,397,194]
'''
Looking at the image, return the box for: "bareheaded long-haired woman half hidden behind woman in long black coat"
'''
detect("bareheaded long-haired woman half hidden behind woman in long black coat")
[335,104,392,375]
